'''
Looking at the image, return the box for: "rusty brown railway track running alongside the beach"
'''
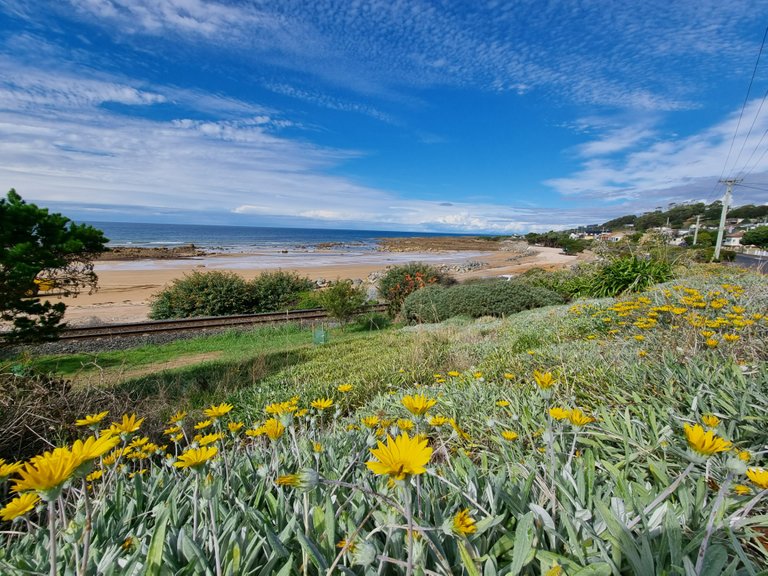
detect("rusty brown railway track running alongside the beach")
[59,304,387,340]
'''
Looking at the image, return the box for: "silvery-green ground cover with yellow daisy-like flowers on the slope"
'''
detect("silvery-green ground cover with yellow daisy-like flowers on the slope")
[0,268,768,575]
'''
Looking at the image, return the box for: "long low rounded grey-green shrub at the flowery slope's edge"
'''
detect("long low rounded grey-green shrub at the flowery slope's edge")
[402,280,565,323]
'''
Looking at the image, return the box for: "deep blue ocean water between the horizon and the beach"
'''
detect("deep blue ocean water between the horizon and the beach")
[88,222,448,252]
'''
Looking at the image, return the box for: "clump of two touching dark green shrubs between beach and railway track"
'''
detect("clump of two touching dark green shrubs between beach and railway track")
[150,271,314,319]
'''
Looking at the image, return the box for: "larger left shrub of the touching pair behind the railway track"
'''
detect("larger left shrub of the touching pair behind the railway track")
[149,271,254,320]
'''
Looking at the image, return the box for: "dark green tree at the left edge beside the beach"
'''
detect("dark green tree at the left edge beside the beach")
[0,190,107,343]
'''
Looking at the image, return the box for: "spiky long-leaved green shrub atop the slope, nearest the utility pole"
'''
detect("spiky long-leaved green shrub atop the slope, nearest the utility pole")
[579,256,672,298]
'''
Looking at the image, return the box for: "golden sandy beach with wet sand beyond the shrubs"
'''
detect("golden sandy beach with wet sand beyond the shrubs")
[58,247,577,326]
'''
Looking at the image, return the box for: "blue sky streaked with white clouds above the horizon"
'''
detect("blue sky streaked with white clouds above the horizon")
[0,0,768,233]
